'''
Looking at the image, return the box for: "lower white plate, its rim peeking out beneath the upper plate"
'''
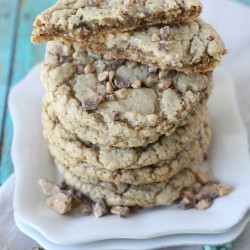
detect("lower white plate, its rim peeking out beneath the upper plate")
[14,213,250,250]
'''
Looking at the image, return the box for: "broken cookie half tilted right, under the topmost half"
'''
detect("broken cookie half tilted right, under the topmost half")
[68,19,226,73]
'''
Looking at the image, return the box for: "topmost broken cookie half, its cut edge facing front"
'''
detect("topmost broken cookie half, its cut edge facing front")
[32,0,202,43]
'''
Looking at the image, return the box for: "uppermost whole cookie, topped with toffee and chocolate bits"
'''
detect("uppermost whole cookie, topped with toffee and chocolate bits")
[41,41,212,147]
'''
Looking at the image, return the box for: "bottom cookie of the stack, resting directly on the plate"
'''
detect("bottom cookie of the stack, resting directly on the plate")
[57,164,195,207]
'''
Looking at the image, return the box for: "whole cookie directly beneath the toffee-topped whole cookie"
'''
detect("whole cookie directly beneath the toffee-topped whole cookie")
[42,101,211,171]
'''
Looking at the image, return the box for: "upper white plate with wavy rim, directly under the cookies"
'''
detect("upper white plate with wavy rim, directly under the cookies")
[9,65,250,245]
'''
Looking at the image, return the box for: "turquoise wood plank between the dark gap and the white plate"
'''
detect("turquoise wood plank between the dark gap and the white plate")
[0,0,55,183]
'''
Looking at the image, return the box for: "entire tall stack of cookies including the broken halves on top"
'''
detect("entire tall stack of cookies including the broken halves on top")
[32,0,225,207]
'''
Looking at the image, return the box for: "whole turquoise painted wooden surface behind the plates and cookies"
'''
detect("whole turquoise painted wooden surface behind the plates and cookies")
[0,0,250,185]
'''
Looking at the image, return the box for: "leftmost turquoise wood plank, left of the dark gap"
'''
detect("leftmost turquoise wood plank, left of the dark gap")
[0,0,19,150]
